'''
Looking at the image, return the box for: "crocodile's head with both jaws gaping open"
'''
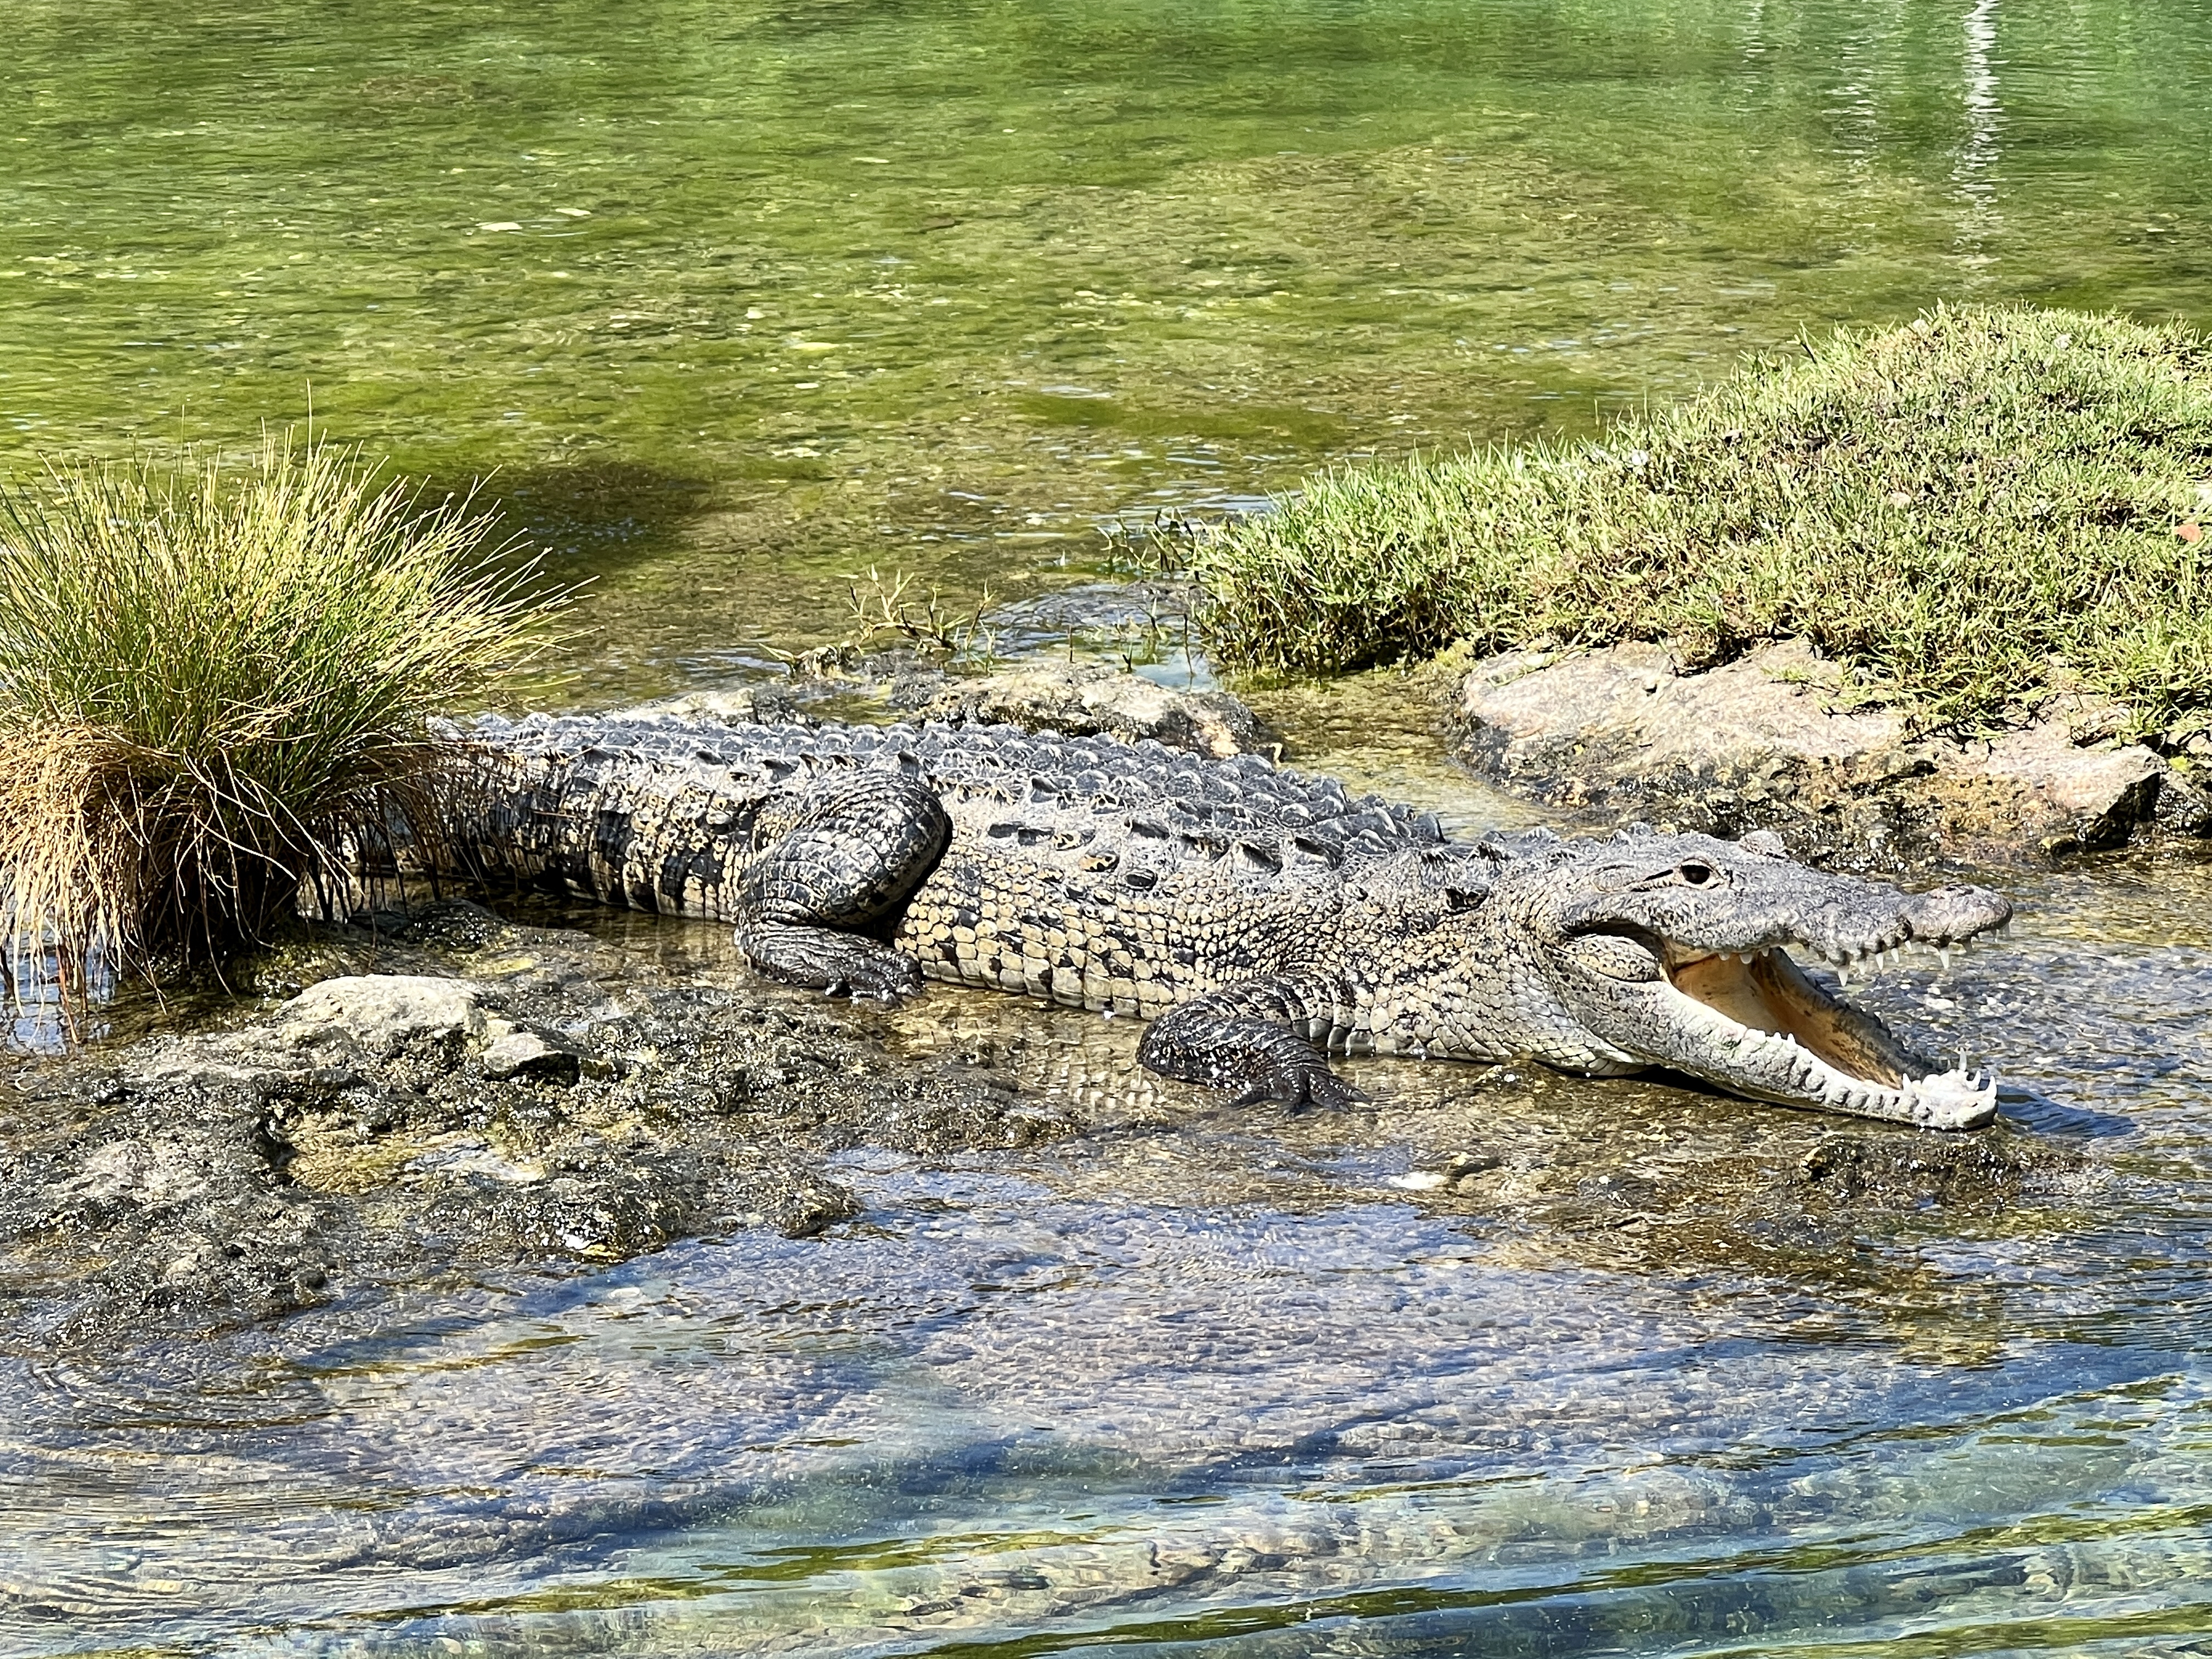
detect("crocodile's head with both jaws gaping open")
[1500,832,2013,1128]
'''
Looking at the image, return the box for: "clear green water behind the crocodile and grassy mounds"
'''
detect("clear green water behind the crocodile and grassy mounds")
[13,0,2212,701]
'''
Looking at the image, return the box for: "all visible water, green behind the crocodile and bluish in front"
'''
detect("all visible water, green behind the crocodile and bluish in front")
[0,0,2212,1659]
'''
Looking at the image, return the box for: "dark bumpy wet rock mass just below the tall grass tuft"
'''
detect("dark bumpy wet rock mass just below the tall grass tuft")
[0,902,1082,1342]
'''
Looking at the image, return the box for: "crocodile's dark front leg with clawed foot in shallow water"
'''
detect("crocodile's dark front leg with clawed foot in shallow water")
[1137,975,1367,1110]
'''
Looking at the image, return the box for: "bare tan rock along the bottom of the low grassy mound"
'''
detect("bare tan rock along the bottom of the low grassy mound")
[1460,639,2212,862]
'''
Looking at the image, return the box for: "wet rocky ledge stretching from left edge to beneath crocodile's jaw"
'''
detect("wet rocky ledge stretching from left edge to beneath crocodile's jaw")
[0,900,2103,1350]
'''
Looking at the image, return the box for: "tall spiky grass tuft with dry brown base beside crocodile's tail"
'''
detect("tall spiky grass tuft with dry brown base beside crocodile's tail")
[0,433,560,982]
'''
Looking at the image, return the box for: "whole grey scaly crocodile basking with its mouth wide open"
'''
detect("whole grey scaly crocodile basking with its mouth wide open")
[433,716,2011,1128]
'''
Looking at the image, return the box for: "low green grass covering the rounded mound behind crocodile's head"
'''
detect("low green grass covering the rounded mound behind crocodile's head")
[1192,307,2212,737]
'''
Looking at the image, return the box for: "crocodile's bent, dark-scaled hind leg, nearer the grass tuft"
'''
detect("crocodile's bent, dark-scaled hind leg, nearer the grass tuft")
[737,772,951,1000]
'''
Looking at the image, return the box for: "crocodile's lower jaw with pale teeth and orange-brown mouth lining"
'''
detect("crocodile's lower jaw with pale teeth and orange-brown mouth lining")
[1661,949,1997,1128]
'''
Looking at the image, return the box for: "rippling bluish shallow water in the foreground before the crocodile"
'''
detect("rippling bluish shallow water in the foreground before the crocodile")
[13,862,2212,1655]
